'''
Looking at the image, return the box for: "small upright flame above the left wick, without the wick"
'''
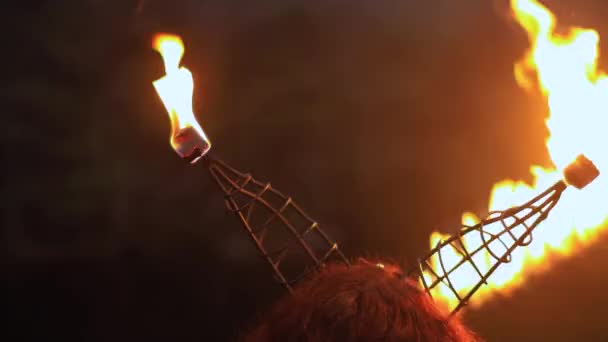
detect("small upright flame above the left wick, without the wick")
[153,34,210,151]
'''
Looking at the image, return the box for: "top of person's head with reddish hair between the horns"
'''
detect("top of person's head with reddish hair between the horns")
[243,260,478,342]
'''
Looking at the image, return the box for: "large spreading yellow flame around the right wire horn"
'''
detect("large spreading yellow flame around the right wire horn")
[423,0,608,308]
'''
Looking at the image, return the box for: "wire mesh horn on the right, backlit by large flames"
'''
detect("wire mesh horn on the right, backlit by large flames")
[408,181,567,314]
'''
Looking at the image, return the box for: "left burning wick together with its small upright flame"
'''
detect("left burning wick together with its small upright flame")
[153,34,211,164]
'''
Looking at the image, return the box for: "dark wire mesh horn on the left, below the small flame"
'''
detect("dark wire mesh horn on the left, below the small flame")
[205,156,349,292]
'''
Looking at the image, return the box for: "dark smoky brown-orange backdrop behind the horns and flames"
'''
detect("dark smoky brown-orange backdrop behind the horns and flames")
[0,0,608,341]
